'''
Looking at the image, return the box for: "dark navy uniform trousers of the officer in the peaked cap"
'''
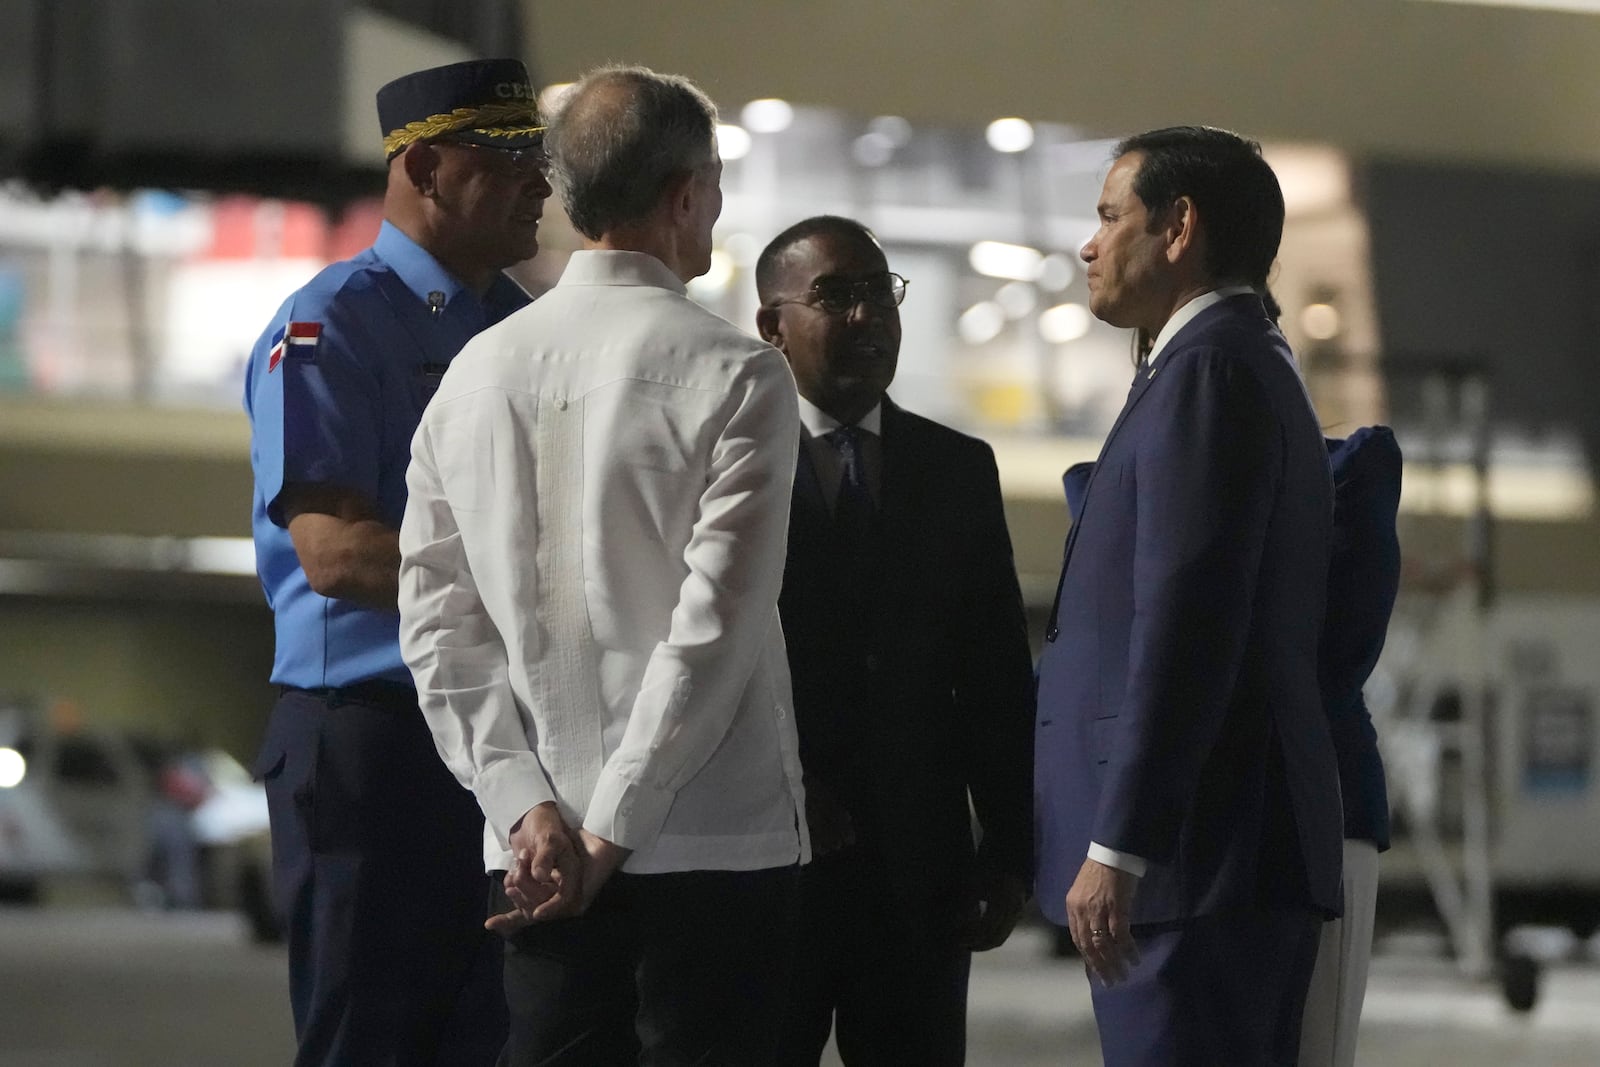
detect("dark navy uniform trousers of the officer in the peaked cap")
[256,683,506,1067]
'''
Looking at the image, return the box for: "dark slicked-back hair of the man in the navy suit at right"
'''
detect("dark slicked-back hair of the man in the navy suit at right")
[1114,126,1283,288]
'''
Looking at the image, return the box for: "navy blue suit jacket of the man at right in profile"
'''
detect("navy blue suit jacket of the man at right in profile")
[1035,296,1342,923]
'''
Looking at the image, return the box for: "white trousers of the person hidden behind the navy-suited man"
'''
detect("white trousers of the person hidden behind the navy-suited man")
[1299,840,1378,1067]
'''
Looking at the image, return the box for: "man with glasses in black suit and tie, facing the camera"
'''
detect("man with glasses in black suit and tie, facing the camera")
[757,216,1034,1067]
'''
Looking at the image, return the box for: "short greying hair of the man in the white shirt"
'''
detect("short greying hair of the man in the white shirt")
[544,67,717,240]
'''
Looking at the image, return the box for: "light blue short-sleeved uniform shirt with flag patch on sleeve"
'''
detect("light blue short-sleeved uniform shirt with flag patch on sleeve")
[245,222,528,688]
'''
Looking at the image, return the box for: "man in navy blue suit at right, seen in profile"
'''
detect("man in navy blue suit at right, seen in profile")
[1035,126,1342,1067]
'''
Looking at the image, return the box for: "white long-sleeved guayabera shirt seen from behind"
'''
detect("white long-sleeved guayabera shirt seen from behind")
[400,251,810,873]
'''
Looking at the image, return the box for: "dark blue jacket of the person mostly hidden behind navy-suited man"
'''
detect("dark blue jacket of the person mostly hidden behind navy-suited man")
[1318,426,1402,849]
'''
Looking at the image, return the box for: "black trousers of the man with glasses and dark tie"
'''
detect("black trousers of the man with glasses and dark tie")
[779,851,971,1067]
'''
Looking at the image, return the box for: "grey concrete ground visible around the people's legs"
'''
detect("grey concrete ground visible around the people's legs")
[0,907,1600,1067]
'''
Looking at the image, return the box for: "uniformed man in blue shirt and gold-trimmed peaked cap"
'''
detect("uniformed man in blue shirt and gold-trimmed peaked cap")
[245,59,550,1067]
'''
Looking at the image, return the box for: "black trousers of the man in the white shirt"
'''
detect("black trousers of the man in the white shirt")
[499,867,795,1067]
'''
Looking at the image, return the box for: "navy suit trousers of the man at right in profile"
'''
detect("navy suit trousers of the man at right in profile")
[1090,910,1322,1067]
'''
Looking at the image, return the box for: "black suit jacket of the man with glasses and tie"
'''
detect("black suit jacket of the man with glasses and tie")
[779,398,1034,926]
